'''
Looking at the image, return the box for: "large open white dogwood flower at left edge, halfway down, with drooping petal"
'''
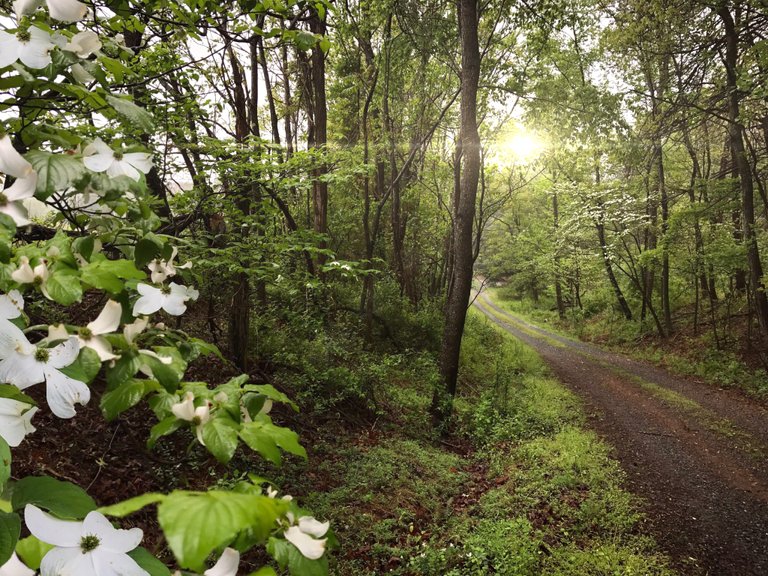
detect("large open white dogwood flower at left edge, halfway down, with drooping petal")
[0,320,91,418]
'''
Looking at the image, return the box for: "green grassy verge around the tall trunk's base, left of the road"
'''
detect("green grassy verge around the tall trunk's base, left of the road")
[295,312,673,576]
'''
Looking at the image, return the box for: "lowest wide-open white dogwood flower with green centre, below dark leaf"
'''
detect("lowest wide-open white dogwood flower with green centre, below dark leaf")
[24,504,149,576]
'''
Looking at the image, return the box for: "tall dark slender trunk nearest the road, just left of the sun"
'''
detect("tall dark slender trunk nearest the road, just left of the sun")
[432,0,480,429]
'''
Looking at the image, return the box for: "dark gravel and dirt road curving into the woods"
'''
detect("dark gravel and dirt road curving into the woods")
[475,294,768,576]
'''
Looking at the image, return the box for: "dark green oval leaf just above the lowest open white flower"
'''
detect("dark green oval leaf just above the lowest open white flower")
[11,476,96,520]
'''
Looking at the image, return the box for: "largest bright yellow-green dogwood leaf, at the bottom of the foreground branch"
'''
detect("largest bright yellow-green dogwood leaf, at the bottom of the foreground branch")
[157,490,288,572]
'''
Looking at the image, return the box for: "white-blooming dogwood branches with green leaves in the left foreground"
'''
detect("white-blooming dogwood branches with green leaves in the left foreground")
[0,0,332,576]
